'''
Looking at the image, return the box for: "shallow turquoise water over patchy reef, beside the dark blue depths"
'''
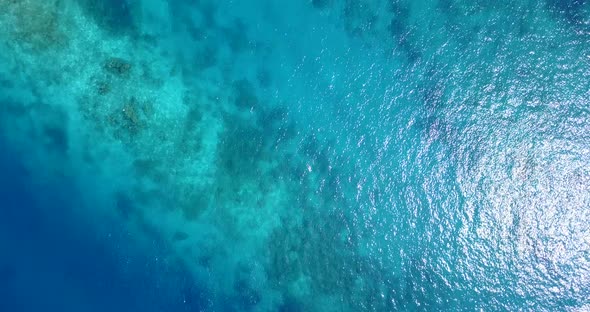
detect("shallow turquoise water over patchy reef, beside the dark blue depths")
[0,0,589,311]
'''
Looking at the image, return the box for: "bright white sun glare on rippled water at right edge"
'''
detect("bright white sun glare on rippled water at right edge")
[458,113,590,296]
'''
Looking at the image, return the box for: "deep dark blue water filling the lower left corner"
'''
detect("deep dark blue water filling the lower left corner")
[0,140,201,311]
